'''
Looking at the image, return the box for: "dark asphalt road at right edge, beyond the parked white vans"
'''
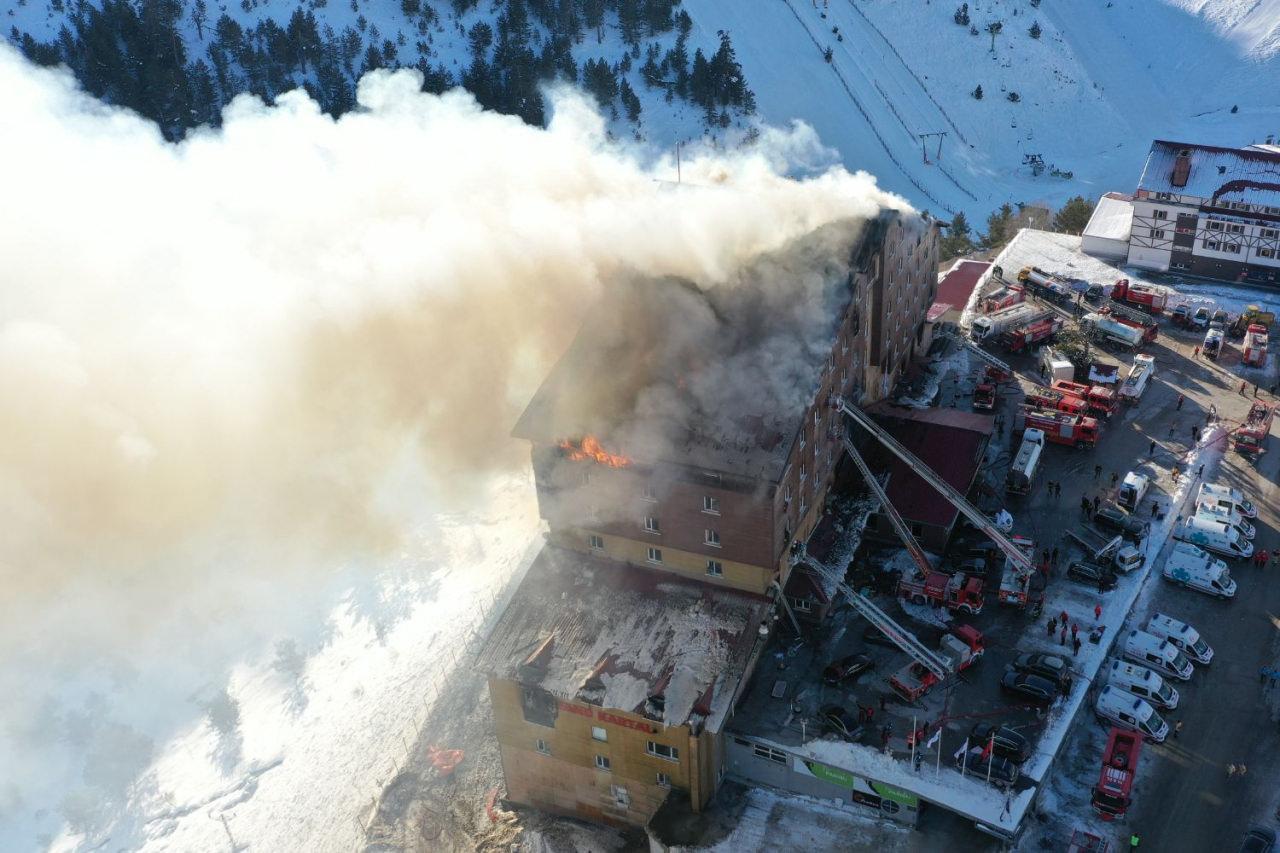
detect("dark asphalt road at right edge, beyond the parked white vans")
[1128,335,1280,850]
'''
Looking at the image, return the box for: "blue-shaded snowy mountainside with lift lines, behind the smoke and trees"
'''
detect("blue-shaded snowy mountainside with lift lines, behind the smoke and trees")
[5,0,1280,222]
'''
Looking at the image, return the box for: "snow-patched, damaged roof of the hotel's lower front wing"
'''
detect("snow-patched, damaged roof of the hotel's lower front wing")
[479,546,769,731]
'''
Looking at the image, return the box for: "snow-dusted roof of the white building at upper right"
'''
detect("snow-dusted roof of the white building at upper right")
[1138,140,1280,206]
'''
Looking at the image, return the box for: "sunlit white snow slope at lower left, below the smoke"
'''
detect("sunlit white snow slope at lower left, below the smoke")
[0,474,541,850]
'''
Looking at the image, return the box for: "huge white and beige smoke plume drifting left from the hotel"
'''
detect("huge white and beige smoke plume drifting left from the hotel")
[0,46,905,824]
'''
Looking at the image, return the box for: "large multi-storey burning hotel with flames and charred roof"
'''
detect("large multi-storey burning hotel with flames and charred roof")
[480,210,938,825]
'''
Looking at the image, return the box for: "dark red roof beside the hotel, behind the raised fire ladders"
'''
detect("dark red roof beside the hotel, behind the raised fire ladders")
[867,403,995,552]
